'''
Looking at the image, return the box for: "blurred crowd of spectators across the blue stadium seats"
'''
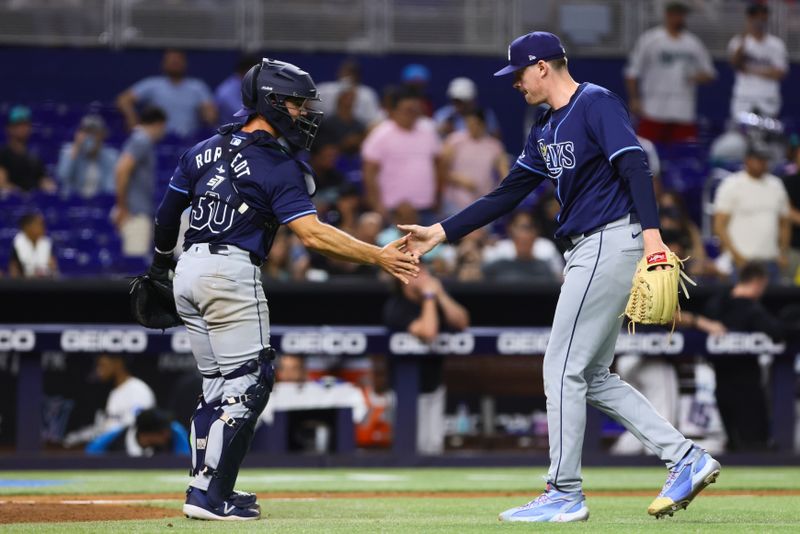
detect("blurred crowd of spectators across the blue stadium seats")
[0,1,800,283]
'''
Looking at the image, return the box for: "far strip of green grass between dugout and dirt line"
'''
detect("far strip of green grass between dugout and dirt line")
[0,466,800,495]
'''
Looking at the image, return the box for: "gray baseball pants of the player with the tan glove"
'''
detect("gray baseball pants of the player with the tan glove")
[544,216,692,492]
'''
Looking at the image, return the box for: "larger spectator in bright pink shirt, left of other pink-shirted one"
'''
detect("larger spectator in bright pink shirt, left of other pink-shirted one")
[361,92,443,224]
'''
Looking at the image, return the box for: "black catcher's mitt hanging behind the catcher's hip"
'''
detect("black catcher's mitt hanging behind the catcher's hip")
[130,274,183,330]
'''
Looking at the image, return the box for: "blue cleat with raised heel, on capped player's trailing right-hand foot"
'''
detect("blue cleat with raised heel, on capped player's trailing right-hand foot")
[647,445,720,519]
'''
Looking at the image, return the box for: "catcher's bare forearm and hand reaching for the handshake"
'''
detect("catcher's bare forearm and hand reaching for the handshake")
[289,215,419,284]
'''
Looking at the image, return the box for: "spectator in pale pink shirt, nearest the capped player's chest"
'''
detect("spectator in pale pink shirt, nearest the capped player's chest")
[442,109,508,216]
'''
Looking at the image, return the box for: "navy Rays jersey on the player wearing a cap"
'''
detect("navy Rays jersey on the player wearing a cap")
[515,83,642,237]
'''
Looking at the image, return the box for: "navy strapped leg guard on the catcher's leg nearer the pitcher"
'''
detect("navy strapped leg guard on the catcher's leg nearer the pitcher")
[191,348,275,506]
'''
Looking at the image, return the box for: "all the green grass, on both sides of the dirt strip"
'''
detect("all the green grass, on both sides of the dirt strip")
[0,467,800,534]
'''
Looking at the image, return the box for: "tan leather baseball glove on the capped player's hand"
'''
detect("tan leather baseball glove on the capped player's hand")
[625,251,697,331]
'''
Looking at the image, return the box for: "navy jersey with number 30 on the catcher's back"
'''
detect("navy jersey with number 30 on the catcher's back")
[169,131,316,261]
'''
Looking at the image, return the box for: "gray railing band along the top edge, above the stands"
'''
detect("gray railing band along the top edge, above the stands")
[0,0,800,61]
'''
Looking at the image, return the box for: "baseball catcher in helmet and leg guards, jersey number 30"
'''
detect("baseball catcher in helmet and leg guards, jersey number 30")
[138,58,419,521]
